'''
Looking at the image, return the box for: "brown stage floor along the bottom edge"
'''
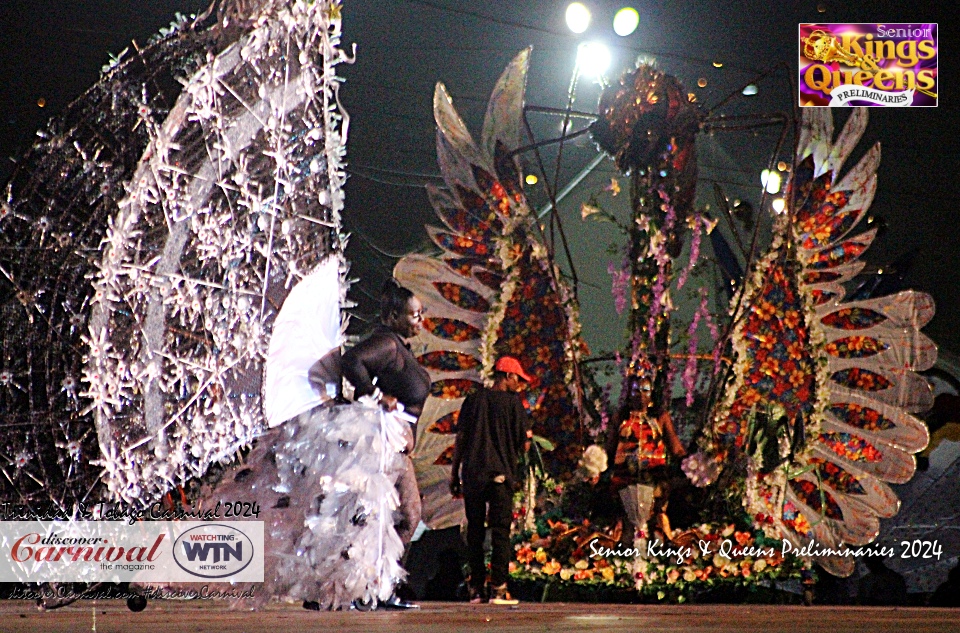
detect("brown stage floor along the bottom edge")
[0,600,960,633]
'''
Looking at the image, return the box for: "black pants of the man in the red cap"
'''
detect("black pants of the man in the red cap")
[463,481,513,588]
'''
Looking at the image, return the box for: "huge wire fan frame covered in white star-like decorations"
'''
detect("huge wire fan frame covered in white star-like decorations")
[0,0,347,508]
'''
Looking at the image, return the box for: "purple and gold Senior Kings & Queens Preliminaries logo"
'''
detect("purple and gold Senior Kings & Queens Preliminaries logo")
[800,23,937,107]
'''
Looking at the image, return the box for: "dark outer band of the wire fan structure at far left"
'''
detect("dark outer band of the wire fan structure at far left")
[0,16,216,509]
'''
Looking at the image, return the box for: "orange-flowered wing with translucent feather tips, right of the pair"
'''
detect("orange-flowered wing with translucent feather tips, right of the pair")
[714,109,936,575]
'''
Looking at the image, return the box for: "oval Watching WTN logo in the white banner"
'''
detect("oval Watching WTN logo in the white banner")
[173,524,255,578]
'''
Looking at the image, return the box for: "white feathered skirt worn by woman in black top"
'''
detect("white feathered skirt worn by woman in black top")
[188,402,409,609]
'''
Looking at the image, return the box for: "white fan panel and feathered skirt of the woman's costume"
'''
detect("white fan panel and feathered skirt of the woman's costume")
[190,258,409,609]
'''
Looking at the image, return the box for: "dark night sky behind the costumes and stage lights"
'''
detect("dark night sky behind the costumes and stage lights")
[0,0,960,351]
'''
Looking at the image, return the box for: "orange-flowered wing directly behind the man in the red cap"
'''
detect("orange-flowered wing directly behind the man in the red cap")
[394,50,579,528]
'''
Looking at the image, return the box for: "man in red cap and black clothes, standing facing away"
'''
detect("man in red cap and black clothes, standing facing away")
[450,356,533,604]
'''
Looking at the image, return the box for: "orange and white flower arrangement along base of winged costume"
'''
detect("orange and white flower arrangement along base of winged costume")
[510,474,804,603]
